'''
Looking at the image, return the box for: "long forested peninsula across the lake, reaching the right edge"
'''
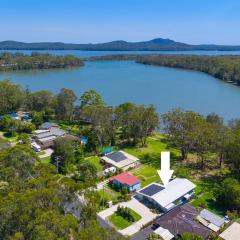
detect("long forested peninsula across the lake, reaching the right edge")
[91,55,240,85]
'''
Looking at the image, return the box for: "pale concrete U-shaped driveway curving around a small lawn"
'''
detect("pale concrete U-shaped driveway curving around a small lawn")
[98,198,157,236]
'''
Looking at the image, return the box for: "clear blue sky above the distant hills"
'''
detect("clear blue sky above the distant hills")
[0,0,240,45]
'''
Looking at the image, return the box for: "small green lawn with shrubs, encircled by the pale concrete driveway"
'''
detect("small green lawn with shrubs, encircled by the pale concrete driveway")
[108,208,141,230]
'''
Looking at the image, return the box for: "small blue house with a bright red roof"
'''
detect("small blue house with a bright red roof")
[109,172,141,192]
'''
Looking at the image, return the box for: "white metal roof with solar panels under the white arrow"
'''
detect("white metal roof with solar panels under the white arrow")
[138,178,196,207]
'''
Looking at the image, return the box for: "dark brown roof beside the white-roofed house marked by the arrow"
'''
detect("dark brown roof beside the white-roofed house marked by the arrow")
[157,204,210,239]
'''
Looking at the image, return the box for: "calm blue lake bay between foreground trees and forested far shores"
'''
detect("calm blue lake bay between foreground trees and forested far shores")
[0,61,240,120]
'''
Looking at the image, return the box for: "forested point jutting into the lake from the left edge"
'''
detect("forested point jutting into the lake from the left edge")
[0,52,83,71]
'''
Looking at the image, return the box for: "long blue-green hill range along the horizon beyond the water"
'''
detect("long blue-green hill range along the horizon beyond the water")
[0,38,240,51]
